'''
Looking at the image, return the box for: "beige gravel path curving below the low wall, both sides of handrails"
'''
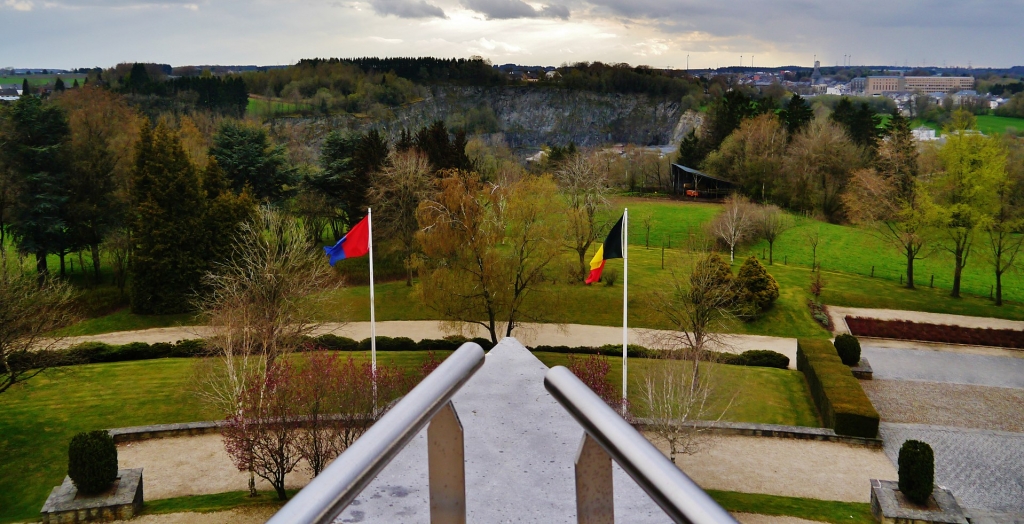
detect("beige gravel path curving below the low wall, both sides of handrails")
[118,435,896,503]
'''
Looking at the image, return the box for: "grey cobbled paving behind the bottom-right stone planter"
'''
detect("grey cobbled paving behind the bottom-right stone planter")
[879,423,1024,515]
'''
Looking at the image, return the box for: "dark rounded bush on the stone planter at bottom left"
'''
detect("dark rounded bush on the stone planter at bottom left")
[68,430,118,494]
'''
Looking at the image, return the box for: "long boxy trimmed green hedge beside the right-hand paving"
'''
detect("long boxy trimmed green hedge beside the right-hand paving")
[797,339,879,438]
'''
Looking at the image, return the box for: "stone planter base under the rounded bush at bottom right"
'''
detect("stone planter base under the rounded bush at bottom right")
[871,479,968,524]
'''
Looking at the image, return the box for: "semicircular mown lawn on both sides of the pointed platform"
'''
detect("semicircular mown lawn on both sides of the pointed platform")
[0,352,818,522]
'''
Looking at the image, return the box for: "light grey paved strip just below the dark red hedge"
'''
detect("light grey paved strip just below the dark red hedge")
[861,344,1024,388]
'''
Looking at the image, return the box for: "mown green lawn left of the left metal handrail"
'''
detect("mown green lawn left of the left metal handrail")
[0,352,445,522]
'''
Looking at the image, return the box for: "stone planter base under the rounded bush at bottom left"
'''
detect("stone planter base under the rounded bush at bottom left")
[41,468,142,524]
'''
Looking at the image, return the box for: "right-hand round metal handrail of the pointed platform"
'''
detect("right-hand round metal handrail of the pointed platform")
[544,365,736,524]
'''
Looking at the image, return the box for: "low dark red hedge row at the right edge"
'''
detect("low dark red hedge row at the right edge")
[846,316,1024,349]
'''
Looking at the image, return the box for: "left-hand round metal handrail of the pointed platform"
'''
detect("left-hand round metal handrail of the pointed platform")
[267,342,483,524]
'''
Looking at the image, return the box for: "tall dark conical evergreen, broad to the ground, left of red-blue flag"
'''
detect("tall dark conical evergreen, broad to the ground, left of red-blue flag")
[129,124,209,314]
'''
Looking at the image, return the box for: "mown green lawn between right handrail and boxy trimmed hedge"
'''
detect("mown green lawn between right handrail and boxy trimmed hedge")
[536,352,820,428]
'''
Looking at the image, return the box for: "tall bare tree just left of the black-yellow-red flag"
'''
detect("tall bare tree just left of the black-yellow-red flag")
[555,154,608,281]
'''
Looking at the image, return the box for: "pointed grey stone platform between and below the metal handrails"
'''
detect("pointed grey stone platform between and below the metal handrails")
[337,338,670,523]
